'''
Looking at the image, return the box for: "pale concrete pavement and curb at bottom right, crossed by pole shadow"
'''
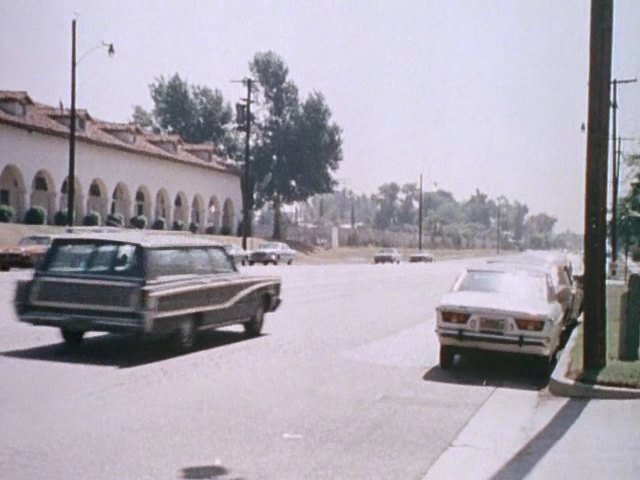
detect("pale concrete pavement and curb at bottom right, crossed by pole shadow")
[423,322,640,480]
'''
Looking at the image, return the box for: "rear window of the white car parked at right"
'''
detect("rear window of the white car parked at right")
[454,270,547,300]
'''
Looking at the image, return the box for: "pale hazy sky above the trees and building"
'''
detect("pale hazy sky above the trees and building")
[0,0,640,231]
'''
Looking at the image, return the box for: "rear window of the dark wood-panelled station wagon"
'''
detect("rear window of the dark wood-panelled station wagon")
[43,242,141,276]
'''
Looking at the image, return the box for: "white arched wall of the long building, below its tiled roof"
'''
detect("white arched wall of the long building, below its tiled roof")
[0,124,242,232]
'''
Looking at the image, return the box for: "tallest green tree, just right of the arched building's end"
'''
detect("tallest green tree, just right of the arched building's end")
[249,52,342,238]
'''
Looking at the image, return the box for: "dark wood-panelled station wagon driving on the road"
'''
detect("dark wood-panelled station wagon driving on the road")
[14,231,280,349]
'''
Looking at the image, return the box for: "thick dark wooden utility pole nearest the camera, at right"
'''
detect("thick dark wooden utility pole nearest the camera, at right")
[583,0,613,369]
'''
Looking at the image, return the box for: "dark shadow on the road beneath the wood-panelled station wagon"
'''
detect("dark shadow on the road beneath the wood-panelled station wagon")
[1,330,260,368]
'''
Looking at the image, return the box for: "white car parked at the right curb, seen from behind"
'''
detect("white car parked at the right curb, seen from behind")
[436,264,571,372]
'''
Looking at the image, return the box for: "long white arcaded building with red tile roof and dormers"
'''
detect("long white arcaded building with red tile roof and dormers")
[0,91,242,233]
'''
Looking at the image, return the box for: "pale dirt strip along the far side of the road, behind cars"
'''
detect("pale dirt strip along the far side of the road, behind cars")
[0,223,492,265]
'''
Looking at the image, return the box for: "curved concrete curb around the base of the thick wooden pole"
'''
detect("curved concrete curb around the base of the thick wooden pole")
[549,324,640,400]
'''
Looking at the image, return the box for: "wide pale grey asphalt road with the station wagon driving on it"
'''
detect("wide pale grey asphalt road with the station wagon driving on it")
[0,261,564,480]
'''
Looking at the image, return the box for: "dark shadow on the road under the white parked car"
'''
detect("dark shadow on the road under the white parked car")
[422,353,549,390]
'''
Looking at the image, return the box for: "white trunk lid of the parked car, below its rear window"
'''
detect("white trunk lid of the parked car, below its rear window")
[438,292,553,316]
